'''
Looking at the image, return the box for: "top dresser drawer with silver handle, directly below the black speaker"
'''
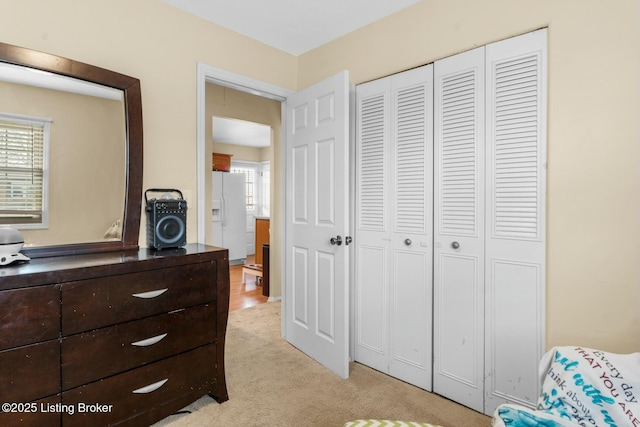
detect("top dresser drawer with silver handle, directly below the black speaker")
[62,262,216,335]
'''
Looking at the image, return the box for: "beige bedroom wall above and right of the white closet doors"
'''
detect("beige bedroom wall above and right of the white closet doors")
[298,0,640,352]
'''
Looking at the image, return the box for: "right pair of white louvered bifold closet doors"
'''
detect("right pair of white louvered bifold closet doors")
[434,30,546,414]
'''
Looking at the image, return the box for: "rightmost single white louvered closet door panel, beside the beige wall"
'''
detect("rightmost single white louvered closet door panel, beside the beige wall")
[485,30,546,412]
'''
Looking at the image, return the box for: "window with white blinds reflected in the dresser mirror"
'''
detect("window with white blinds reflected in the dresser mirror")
[0,116,49,225]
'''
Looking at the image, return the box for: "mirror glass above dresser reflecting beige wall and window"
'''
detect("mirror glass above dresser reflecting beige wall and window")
[0,60,127,248]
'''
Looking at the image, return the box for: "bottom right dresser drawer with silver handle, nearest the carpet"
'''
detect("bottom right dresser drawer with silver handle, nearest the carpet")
[62,344,216,427]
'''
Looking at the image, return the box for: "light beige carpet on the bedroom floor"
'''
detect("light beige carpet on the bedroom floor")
[155,302,491,427]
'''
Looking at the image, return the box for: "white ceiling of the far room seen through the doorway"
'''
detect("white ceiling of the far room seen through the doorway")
[213,117,271,147]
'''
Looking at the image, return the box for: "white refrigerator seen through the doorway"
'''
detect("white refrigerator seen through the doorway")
[212,172,247,265]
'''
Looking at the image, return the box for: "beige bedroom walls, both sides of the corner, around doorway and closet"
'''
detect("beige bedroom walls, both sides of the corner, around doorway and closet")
[0,0,640,352]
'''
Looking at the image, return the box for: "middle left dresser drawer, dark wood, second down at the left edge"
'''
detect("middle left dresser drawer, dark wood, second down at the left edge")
[0,340,60,403]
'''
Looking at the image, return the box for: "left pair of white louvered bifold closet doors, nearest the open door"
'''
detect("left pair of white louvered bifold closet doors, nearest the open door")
[355,65,433,390]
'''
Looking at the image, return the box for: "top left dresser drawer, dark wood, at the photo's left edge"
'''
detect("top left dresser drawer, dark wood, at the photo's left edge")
[0,285,60,350]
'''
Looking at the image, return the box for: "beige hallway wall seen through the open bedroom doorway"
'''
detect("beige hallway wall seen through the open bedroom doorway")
[205,83,282,297]
